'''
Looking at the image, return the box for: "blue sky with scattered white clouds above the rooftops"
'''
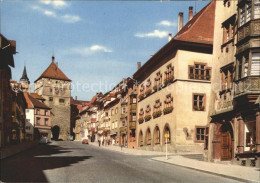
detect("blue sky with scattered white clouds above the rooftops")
[0,0,209,100]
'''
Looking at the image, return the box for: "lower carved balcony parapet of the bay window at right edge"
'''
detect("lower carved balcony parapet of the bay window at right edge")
[235,76,260,96]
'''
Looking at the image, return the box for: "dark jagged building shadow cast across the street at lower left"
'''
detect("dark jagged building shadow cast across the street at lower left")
[0,144,92,182]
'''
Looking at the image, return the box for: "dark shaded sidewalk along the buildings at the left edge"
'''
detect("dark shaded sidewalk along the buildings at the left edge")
[0,141,39,159]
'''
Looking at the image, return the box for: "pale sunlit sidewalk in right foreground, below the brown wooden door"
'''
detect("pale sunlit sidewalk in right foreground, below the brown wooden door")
[152,155,260,182]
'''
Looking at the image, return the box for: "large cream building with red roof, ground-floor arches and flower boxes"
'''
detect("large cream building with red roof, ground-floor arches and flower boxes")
[133,1,215,152]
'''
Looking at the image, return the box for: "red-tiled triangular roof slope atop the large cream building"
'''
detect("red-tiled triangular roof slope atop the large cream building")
[174,0,216,44]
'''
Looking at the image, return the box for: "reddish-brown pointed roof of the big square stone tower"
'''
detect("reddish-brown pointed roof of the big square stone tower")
[34,56,71,82]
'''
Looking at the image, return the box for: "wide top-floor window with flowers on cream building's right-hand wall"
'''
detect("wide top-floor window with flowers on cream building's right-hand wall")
[189,64,211,80]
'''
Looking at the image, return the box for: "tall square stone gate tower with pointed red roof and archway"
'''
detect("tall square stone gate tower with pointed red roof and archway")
[34,56,71,140]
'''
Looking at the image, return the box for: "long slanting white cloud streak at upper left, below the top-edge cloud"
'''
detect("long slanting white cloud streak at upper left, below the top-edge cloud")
[31,6,81,23]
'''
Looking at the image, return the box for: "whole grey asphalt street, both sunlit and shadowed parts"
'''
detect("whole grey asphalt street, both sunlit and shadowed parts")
[1,141,244,183]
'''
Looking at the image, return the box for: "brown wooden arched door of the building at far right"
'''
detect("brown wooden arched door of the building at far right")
[221,131,232,160]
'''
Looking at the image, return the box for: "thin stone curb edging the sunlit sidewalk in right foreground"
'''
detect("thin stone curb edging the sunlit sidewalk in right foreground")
[151,158,259,183]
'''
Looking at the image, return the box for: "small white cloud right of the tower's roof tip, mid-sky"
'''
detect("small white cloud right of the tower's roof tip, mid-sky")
[72,45,112,56]
